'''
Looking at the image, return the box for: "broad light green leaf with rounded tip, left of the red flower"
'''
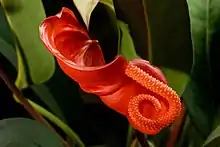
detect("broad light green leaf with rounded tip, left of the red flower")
[1,0,55,84]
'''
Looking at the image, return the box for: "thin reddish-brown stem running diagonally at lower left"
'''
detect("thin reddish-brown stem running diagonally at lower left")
[0,65,69,147]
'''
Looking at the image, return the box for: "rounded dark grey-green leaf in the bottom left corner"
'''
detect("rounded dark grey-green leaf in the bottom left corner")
[0,118,64,147]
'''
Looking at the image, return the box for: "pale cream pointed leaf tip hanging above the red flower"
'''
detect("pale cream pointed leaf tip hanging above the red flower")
[73,0,99,27]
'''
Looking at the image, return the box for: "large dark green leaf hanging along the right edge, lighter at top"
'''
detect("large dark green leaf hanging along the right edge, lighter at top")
[183,0,220,137]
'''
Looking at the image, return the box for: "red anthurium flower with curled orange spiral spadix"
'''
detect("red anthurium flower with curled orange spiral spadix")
[40,8,181,134]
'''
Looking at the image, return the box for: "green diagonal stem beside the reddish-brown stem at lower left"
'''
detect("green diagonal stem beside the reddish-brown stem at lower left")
[28,100,85,147]
